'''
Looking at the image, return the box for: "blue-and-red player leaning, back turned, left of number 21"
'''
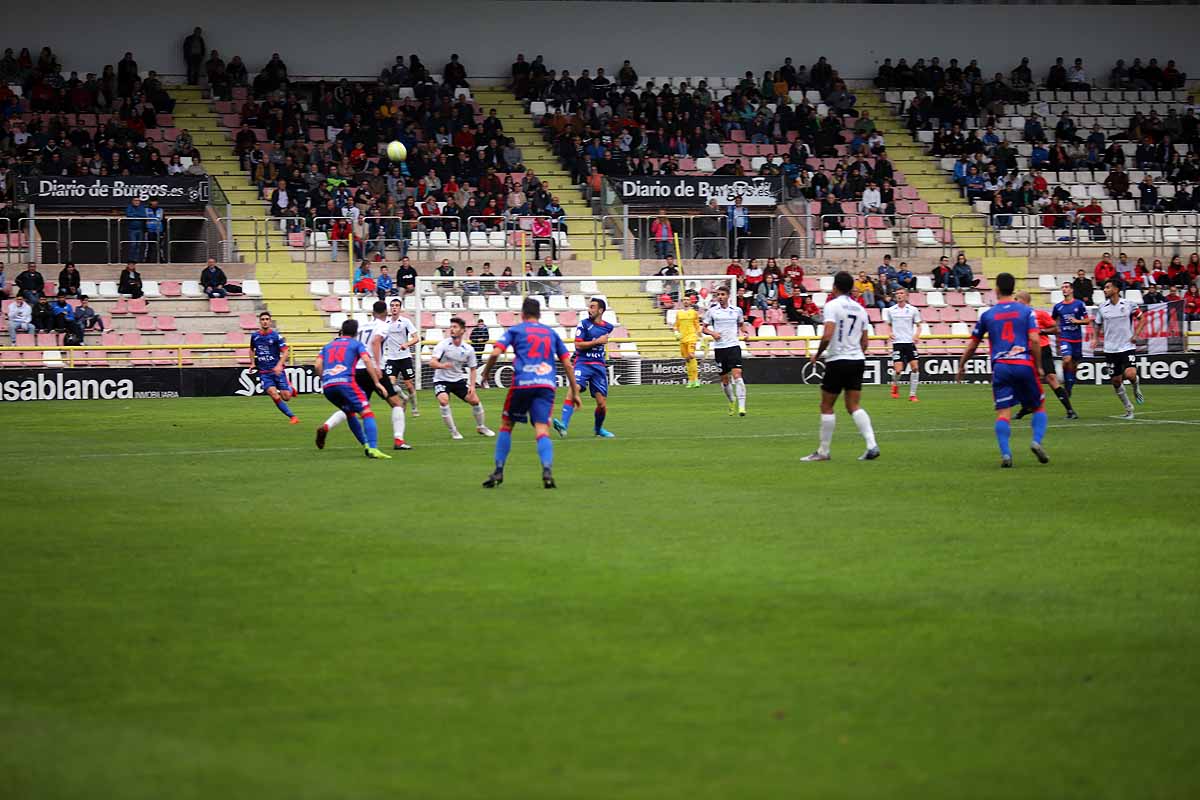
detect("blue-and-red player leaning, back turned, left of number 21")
[316,319,391,458]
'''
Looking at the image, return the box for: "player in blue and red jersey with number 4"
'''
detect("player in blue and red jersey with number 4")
[958,272,1050,468]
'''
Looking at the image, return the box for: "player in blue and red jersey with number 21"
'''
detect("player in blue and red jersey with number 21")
[484,297,580,489]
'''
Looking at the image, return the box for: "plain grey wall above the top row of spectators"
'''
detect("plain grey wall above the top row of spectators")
[11,0,1200,80]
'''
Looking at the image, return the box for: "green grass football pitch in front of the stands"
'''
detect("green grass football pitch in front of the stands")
[0,385,1200,800]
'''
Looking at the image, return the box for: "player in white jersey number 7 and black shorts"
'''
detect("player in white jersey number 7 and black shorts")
[800,271,880,461]
